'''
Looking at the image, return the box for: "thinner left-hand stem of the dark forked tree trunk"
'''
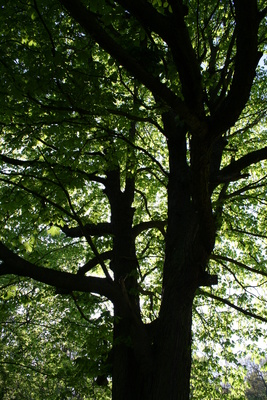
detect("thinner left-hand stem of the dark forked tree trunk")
[106,169,155,400]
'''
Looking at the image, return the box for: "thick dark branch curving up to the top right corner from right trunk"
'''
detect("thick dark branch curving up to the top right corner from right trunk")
[210,0,262,135]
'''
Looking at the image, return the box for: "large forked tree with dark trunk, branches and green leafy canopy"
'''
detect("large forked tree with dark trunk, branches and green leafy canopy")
[0,0,267,400]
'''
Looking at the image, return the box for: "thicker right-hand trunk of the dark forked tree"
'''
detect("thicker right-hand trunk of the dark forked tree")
[149,113,216,400]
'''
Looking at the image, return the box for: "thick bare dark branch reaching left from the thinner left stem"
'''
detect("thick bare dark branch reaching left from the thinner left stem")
[0,242,116,301]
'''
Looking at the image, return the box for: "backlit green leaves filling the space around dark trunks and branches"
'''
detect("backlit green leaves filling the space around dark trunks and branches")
[0,0,267,399]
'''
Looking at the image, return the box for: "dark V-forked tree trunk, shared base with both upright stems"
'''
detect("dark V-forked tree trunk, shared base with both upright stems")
[109,113,216,400]
